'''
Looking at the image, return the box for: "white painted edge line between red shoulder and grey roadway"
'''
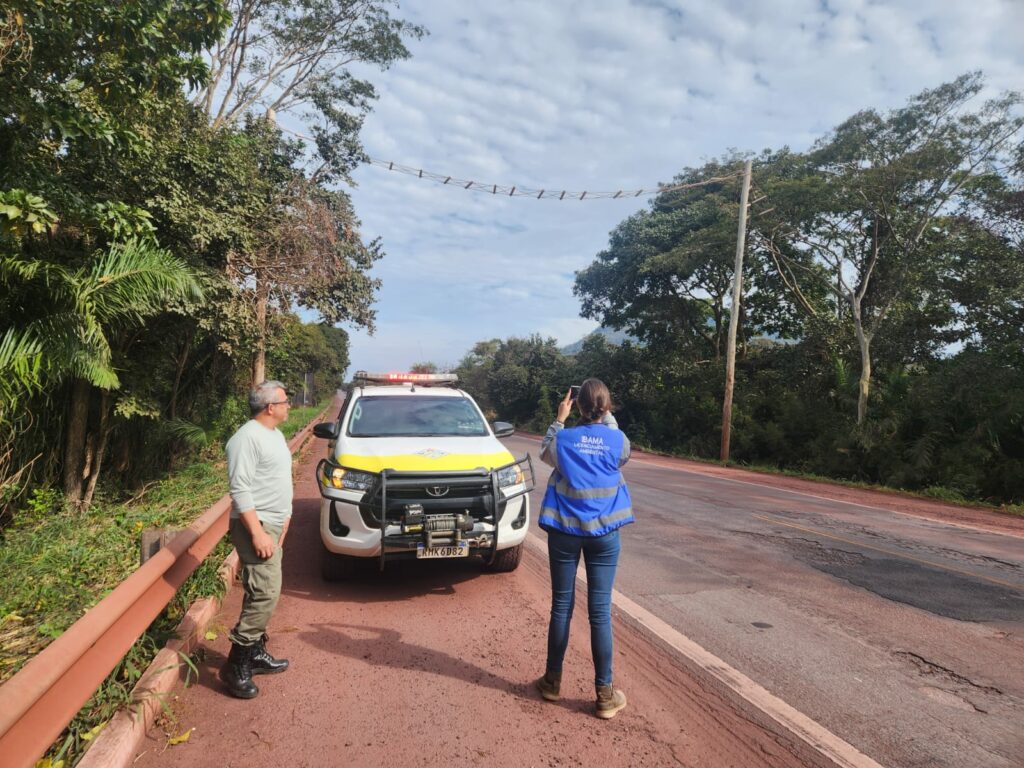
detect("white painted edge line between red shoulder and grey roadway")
[526,531,883,768]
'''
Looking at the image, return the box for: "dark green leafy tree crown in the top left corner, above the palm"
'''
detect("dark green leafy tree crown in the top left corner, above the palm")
[0,0,228,201]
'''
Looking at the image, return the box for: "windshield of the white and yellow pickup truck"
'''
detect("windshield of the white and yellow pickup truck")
[348,395,487,437]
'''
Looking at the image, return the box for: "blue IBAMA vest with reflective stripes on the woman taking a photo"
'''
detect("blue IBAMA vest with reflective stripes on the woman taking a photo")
[538,424,635,537]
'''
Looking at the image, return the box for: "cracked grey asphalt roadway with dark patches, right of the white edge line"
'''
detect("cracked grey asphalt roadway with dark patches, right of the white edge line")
[506,436,1024,768]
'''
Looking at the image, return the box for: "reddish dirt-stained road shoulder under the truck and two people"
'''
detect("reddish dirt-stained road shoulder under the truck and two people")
[134,440,831,768]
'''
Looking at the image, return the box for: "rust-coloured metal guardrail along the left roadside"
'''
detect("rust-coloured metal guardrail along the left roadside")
[0,403,325,768]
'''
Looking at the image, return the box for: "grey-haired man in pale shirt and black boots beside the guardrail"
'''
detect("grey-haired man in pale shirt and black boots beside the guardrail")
[220,381,292,698]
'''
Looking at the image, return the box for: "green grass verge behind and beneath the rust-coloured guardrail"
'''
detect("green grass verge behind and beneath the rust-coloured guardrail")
[0,406,324,767]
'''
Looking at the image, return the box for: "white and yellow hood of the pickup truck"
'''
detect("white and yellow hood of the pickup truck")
[335,435,515,472]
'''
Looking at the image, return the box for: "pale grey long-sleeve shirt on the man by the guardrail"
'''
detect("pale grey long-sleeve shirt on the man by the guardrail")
[225,419,293,526]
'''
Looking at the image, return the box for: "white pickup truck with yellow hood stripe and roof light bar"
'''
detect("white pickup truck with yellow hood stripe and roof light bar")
[313,372,534,581]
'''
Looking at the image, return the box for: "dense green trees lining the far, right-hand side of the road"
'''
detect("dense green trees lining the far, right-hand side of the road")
[452,73,1024,512]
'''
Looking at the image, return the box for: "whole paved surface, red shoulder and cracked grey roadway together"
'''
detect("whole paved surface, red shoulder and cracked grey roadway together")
[136,436,1024,768]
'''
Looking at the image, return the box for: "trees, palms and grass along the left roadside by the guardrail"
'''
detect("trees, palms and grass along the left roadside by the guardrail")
[0,0,425,765]
